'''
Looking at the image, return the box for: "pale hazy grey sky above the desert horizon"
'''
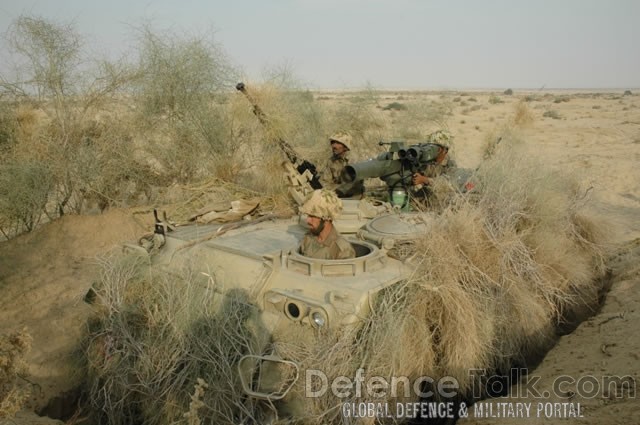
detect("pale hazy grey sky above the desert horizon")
[0,0,640,89]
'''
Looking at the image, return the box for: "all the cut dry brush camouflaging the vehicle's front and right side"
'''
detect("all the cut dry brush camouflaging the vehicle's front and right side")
[82,137,605,424]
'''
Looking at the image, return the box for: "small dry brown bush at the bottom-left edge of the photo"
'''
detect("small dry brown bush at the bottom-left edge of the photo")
[0,330,32,422]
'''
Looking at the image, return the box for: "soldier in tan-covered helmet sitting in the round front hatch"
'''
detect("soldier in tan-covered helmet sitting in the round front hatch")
[300,189,356,260]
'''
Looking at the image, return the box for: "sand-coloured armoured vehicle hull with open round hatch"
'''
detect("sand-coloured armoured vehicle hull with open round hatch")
[125,192,433,408]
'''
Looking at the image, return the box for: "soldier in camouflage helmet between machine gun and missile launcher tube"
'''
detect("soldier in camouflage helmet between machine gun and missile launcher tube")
[322,133,364,198]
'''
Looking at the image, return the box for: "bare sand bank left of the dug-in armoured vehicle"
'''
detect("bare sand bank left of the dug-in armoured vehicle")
[0,210,149,418]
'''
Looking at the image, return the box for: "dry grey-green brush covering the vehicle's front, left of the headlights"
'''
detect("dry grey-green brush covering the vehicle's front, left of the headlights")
[85,252,260,424]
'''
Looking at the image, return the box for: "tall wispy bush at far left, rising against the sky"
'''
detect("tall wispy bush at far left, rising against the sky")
[2,16,141,220]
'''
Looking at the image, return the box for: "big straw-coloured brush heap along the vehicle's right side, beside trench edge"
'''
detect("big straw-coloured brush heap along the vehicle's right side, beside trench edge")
[400,145,603,386]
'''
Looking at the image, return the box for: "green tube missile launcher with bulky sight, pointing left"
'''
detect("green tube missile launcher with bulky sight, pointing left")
[342,141,443,207]
